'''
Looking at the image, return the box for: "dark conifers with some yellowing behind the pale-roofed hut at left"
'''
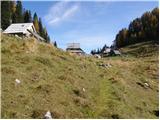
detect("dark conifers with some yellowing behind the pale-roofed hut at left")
[1,1,50,43]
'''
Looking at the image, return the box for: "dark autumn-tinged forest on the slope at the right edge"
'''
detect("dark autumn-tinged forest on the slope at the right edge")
[114,8,159,48]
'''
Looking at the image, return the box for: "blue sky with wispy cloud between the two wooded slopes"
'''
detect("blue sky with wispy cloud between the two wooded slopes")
[23,1,158,53]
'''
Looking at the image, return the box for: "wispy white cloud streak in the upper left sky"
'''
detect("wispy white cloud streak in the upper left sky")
[44,1,79,25]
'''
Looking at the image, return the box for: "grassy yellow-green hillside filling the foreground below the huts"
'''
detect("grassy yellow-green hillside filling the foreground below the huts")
[1,34,159,118]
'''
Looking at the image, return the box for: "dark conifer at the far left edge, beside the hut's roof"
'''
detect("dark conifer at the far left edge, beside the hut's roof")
[1,1,11,30]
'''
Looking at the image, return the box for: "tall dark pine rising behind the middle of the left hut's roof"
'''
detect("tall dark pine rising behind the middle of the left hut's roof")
[15,1,24,23]
